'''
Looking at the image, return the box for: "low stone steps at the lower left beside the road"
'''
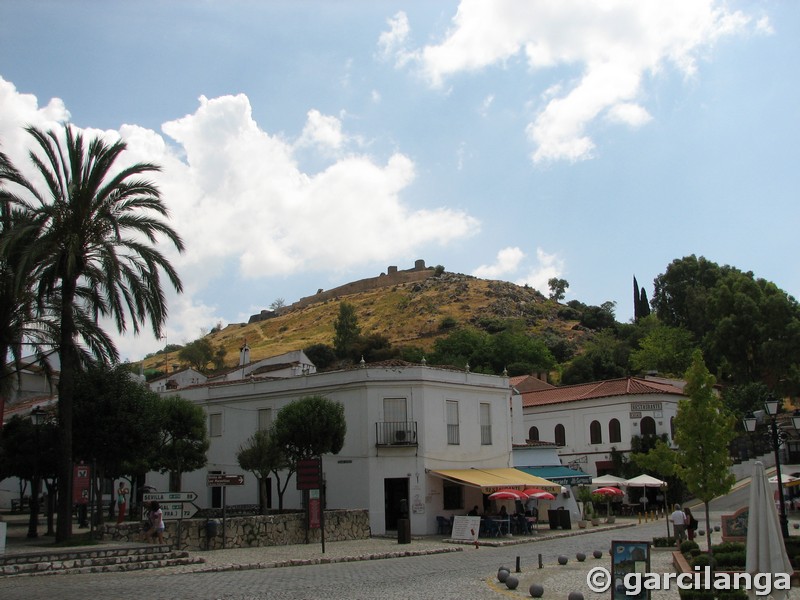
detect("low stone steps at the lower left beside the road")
[0,545,205,577]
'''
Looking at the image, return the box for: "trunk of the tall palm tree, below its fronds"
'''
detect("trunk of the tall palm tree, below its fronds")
[56,280,80,542]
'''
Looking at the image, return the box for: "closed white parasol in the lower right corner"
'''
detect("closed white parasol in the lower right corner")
[745,462,792,600]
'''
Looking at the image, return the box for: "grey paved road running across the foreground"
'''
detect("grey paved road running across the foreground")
[0,519,677,600]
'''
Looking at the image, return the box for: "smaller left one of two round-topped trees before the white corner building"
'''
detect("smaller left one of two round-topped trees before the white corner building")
[236,429,295,514]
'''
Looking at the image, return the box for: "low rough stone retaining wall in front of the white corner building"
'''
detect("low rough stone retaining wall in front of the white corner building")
[103,509,371,550]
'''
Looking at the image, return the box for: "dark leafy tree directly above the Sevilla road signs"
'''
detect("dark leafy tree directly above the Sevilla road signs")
[150,396,209,492]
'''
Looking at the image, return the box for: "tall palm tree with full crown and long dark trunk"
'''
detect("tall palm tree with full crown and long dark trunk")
[0,124,183,541]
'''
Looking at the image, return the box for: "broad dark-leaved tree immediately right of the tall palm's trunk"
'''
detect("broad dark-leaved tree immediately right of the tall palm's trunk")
[73,365,160,523]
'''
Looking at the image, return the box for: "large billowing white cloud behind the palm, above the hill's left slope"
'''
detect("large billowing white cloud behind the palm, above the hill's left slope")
[0,78,479,358]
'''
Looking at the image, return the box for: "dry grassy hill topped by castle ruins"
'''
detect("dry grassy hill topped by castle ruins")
[138,269,585,369]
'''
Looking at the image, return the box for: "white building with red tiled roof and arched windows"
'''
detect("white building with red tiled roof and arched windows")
[520,377,685,476]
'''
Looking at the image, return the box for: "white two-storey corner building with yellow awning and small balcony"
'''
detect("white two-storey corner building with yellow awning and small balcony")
[153,361,560,534]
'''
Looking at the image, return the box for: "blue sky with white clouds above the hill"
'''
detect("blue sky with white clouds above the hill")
[0,0,800,361]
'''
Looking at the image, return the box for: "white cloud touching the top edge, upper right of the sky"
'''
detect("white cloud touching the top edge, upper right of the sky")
[396,0,771,163]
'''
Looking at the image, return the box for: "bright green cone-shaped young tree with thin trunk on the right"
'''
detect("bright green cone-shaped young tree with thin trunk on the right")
[675,350,735,549]
